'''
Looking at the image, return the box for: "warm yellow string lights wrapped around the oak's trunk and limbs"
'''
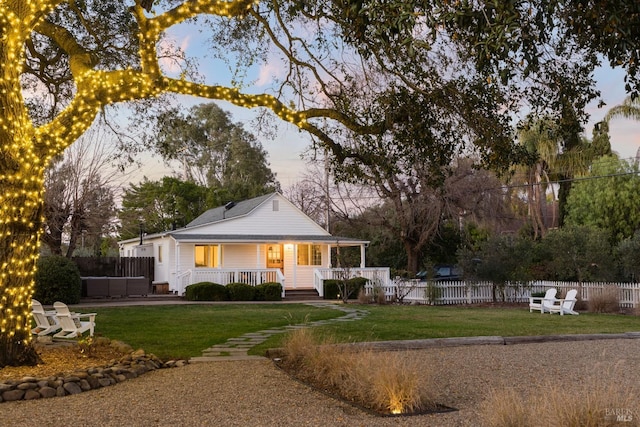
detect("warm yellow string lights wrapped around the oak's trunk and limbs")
[0,0,344,367]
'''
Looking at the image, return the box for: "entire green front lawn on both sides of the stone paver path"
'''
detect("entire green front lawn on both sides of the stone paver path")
[83,304,640,359]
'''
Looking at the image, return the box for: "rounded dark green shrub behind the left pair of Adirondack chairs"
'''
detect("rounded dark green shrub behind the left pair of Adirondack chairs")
[33,255,82,304]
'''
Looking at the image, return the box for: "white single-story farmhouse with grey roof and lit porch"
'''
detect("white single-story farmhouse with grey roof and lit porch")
[119,193,389,295]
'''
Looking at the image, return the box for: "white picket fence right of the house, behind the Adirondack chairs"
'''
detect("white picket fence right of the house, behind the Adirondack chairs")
[365,279,640,308]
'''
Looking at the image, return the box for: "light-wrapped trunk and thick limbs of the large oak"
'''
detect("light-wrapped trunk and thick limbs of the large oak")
[0,0,380,366]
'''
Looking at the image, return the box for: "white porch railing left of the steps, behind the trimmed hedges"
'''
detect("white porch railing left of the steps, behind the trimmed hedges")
[176,268,284,298]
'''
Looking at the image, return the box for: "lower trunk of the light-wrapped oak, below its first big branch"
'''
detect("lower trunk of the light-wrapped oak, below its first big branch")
[0,131,44,368]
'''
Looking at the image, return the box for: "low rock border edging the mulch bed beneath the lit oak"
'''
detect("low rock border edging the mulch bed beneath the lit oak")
[0,350,189,403]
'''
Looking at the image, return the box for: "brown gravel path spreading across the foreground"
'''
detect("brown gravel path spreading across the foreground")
[0,339,640,427]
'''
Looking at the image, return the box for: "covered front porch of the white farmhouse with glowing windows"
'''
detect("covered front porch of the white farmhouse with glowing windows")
[168,234,376,295]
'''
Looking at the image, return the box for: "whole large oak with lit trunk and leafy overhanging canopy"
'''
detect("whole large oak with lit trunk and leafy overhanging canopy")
[0,0,640,366]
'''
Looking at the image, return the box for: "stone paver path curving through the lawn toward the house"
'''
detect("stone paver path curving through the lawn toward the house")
[189,302,369,362]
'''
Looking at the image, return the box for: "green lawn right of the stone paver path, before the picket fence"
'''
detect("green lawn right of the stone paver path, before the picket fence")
[251,305,640,354]
